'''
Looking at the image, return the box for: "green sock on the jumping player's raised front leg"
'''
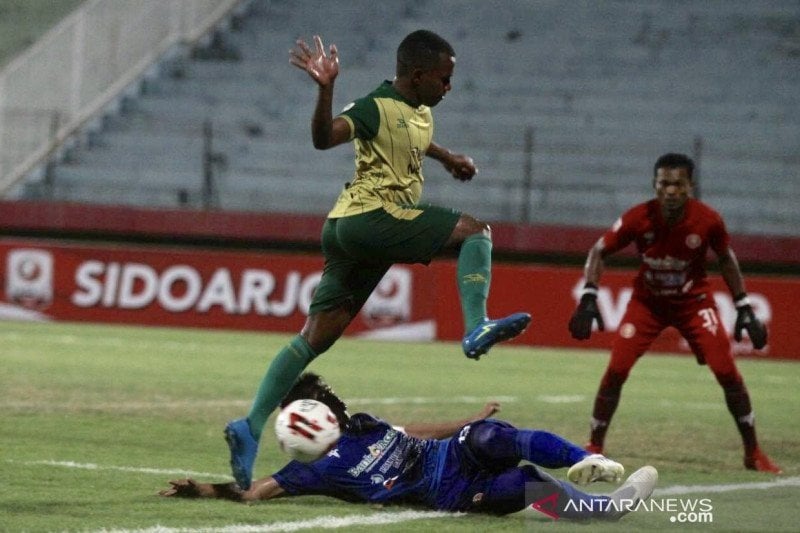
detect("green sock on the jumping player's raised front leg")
[456,233,492,333]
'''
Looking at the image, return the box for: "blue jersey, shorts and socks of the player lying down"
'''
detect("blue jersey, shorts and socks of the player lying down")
[273,413,606,517]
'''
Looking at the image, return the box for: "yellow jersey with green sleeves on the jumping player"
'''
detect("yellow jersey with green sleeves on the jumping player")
[328,81,433,218]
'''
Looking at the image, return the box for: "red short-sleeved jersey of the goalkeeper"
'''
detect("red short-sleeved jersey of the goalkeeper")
[603,198,730,298]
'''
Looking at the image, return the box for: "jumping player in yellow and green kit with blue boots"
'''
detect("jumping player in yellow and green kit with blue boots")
[225,30,531,490]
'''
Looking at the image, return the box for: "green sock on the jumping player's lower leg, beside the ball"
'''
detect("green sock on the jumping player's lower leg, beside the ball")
[247,335,317,440]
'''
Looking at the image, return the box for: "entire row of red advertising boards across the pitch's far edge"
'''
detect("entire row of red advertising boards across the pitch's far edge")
[0,239,800,359]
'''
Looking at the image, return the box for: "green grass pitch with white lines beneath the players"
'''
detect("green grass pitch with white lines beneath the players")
[0,322,800,533]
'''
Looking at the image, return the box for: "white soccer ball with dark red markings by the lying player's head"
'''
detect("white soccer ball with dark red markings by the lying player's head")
[275,400,341,463]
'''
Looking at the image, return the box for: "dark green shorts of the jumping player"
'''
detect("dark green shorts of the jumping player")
[309,206,461,315]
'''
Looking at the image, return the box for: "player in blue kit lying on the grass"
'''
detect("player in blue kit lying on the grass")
[159,374,658,520]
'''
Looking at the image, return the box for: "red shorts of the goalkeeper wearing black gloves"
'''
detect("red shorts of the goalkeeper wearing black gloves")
[608,294,738,376]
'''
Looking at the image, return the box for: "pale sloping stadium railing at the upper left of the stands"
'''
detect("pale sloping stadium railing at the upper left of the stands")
[0,0,246,193]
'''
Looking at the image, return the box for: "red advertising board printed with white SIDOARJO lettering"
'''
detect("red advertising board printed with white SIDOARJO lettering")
[0,240,434,339]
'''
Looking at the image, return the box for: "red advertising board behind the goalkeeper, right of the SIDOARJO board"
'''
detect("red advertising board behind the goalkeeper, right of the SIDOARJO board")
[428,263,800,359]
